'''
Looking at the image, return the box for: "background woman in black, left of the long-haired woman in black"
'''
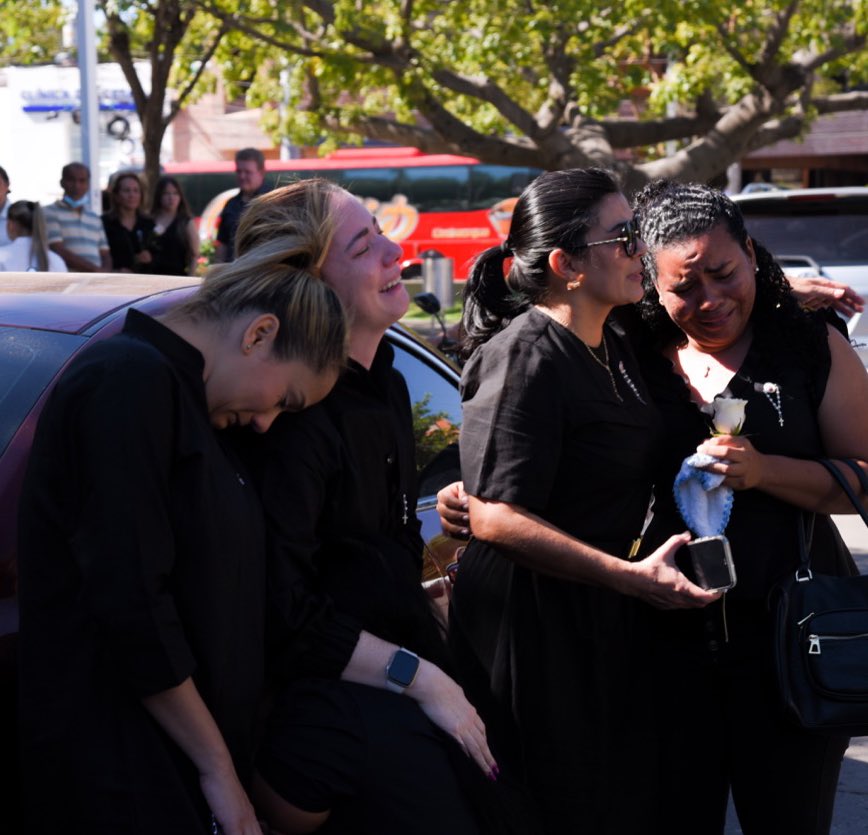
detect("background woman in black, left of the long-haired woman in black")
[102,171,154,273]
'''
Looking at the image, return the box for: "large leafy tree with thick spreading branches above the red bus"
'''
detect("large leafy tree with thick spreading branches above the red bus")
[200,0,868,189]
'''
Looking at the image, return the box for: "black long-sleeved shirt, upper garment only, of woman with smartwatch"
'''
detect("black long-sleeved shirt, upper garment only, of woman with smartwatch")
[252,340,442,677]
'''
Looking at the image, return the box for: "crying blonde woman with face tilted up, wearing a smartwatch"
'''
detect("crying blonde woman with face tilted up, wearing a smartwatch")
[227,179,508,835]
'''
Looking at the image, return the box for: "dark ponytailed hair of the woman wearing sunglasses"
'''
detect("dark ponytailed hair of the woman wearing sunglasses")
[462,168,619,357]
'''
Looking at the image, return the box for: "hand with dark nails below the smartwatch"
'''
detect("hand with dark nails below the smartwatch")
[404,659,499,779]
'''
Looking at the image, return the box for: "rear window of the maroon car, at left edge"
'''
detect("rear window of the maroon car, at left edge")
[0,328,85,455]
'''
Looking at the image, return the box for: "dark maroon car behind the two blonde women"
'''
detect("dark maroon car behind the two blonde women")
[0,273,461,833]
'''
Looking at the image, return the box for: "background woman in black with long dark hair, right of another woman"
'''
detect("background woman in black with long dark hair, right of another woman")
[148,177,199,275]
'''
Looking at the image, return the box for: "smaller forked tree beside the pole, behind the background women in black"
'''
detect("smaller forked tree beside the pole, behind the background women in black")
[100,0,228,197]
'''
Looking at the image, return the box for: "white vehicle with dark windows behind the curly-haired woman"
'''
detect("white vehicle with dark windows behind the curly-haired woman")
[732,186,868,297]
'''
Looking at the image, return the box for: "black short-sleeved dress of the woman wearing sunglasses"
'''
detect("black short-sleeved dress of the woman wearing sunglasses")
[450,310,659,835]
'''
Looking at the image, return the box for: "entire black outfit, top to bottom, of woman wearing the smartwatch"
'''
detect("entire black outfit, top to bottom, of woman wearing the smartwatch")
[248,340,482,835]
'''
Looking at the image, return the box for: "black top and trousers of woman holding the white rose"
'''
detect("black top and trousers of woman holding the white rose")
[641,321,855,835]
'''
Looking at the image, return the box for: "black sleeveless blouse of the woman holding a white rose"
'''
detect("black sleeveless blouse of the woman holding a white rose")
[641,318,850,604]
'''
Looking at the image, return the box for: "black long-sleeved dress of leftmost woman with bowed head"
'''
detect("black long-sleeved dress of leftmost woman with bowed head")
[19,311,265,835]
